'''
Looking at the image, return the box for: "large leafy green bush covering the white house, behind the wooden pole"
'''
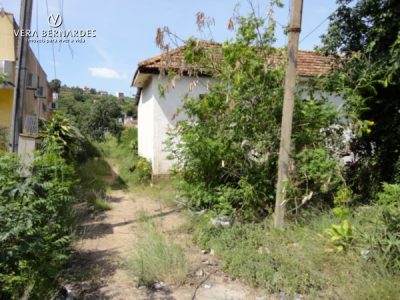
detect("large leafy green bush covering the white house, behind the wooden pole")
[168,4,343,220]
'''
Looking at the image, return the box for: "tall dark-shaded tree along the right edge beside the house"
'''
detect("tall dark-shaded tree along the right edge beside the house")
[322,0,400,198]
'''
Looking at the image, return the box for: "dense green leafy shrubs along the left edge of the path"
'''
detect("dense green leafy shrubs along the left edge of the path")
[0,117,78,299]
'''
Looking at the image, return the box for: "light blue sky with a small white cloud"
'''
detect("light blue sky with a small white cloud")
[0,0,336,96]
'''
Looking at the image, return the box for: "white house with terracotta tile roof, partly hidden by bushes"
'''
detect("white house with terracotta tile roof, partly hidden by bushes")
[132,43,338,175]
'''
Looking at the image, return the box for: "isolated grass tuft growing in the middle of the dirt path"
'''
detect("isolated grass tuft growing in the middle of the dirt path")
[126,211,188,286]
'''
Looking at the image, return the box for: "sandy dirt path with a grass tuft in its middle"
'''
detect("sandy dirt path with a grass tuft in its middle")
[67,183,269,300]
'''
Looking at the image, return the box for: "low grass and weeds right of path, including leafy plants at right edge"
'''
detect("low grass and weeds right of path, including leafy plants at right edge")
[192,194,400,299]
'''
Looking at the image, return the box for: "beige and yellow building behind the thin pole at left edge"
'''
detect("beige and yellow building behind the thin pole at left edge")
[0,11,52,141]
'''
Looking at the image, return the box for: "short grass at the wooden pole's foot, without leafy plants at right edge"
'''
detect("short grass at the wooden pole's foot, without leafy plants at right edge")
[192,213,400,299]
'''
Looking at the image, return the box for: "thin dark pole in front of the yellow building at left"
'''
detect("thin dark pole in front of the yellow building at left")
[10,0,32,152]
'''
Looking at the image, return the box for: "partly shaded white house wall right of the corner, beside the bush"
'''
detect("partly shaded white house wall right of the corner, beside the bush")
[151,75,212,175]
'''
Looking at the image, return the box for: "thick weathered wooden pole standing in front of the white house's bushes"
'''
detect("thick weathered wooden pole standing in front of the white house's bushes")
[274,0,303,229]
